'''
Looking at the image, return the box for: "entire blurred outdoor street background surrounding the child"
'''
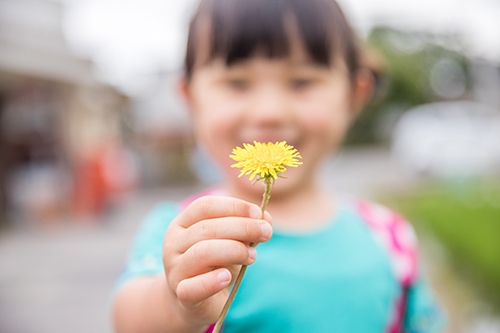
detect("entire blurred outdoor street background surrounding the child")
[0,0,500,333]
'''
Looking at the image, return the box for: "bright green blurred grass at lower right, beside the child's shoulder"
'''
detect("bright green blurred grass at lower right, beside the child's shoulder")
[383,183,500,309]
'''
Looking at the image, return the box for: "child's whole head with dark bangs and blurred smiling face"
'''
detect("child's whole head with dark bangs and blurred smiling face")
[182,0,370,198]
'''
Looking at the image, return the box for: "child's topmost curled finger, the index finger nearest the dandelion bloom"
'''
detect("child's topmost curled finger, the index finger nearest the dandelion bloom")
[176,196,270,228]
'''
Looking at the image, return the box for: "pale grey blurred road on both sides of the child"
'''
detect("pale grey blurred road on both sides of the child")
[0,148,422,333]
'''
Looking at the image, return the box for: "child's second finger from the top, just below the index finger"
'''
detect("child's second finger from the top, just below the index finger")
[177,217,273,253]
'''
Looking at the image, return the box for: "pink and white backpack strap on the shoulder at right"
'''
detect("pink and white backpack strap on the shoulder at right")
[355,199,418,333]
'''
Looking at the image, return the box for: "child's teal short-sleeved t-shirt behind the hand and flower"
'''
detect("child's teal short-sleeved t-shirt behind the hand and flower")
[113,196,445,333]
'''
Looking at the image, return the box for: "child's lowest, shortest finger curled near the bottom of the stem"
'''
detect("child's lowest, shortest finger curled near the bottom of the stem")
[176,268,232,308]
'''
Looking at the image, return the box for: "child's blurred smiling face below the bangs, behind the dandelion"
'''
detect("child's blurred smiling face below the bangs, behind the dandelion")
[185,56,364,194]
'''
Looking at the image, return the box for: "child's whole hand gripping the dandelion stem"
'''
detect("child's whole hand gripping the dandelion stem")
[163,197,272,324]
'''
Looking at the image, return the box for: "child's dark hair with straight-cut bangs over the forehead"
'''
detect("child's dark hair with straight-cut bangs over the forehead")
[184,0,360,80]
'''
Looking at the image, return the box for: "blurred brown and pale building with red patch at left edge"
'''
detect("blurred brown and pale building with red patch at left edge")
[0,0,129,226]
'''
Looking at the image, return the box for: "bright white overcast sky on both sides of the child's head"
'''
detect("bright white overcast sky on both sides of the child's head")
[63,0,500,93]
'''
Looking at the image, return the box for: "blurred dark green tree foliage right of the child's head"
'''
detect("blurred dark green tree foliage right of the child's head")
[347,27,468,144]
